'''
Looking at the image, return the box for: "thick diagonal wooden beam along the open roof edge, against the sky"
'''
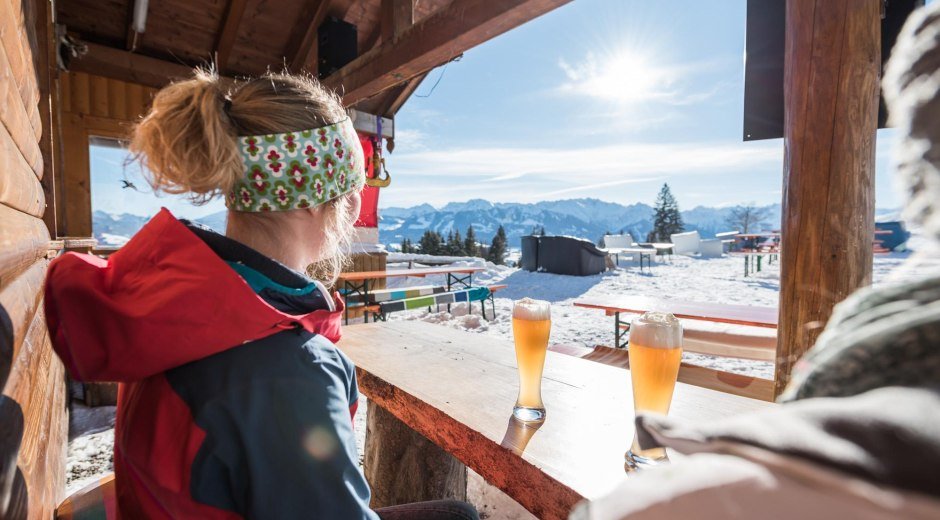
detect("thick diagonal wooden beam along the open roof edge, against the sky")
[324,0,570,105]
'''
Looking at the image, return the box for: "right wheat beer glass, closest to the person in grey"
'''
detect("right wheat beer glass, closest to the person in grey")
[625,312,682,471]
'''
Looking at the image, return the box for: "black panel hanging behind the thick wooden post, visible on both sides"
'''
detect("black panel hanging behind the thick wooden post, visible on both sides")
[744,0,924,141]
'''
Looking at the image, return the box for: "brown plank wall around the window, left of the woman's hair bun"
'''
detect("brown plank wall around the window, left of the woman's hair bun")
[58,72,157,237]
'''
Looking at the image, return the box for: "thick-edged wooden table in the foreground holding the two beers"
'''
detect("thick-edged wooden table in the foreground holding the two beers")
[339,322,773,519]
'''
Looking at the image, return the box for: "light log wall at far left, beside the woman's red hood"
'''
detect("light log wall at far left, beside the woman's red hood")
[0,0,68,519]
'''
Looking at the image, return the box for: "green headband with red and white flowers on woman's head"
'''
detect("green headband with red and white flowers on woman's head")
[226,119,365,212]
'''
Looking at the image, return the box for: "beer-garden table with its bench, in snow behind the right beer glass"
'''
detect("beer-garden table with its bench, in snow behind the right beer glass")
[574,296,778,361]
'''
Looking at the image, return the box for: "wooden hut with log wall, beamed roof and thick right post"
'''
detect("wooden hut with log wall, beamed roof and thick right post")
[0,0,882,518]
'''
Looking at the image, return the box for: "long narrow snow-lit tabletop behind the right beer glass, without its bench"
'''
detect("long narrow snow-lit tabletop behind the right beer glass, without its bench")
[574,296,778,348]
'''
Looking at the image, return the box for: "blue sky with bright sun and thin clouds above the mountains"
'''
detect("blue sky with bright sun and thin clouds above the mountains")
[92,0,900,216]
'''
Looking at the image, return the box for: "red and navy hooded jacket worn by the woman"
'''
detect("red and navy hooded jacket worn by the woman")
[45,209,373,518]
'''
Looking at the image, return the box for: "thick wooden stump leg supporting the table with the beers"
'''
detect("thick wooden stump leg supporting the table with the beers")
[365,402,467,508]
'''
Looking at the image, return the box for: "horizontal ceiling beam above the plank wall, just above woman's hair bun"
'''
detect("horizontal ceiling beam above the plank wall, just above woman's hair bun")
[69,43,234,88]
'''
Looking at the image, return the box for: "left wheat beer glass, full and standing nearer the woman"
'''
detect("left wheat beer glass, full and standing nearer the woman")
[512,298,552,422]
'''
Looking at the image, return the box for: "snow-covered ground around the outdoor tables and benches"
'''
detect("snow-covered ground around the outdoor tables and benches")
[67,248,940,519]
